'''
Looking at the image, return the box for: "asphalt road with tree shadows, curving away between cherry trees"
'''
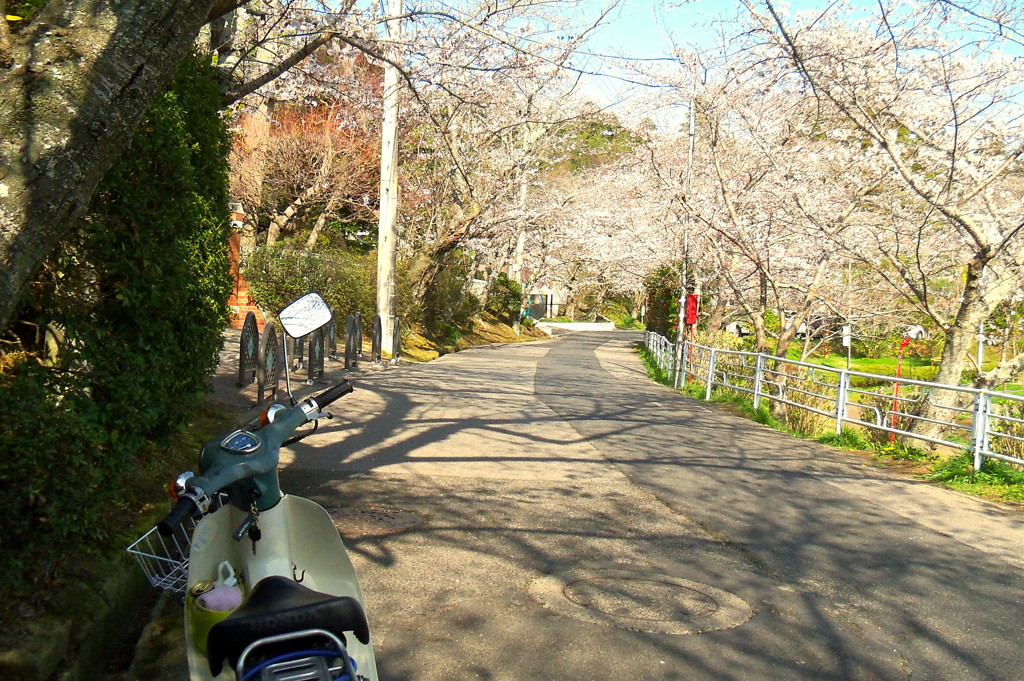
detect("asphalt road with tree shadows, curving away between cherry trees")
[266,333,1024,681]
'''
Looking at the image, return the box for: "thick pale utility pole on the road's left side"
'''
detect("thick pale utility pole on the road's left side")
[377,0,401,355]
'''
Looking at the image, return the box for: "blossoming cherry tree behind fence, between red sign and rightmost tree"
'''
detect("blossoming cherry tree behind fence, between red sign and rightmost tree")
[634,43,874,356]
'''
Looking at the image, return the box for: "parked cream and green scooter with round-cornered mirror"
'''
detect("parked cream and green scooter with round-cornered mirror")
[146,294,378,681]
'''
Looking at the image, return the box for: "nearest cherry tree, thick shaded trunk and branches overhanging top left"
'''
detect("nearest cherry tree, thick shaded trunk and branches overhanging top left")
[0,0,600,328]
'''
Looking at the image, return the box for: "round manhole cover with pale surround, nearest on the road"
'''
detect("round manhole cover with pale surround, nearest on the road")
[529,569,754,634]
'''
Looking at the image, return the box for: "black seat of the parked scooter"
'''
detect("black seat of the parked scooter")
[206,576,370,676]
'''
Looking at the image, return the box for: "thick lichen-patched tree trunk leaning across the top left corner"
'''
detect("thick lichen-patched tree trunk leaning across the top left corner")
[0,0,237,330]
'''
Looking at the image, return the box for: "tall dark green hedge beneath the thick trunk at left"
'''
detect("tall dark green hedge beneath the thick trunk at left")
[0,51,231,583]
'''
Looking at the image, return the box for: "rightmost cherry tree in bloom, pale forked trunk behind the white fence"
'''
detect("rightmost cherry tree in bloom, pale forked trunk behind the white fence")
[744,0,1024,401]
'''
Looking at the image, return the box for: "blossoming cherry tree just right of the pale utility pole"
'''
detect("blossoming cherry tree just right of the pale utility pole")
[402,68,610,299]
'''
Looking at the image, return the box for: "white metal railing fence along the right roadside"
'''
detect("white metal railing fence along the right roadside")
[644,331,1024,470]
